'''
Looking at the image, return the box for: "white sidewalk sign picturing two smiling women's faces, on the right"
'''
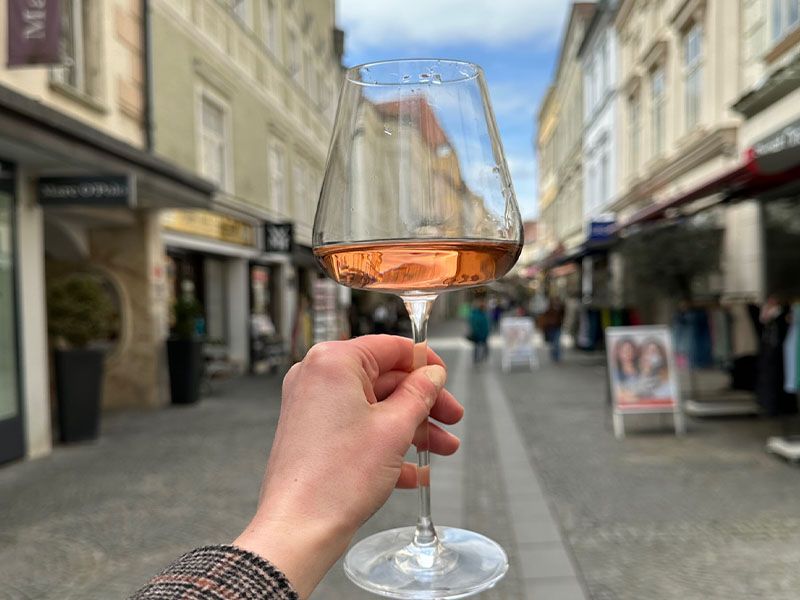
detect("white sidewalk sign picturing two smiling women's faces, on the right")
[605,326,686,439]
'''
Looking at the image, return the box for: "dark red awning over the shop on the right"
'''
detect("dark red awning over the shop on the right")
[615,148,800,232]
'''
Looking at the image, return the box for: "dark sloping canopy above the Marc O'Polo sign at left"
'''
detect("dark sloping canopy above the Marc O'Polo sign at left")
[0,86,216,208]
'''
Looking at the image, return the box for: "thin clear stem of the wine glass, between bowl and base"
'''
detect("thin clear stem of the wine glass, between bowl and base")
[403,295,439,547]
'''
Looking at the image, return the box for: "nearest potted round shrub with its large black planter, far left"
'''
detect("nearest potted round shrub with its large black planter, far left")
[47,273,116,442]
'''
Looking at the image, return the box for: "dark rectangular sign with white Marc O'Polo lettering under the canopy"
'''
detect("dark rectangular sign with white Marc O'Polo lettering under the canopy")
[38,175,136,207]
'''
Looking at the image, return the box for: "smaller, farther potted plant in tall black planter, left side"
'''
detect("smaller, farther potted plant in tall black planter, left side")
[167,282,203,404]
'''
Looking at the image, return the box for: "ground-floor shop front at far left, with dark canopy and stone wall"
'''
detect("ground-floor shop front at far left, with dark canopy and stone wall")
[0,87,214,461]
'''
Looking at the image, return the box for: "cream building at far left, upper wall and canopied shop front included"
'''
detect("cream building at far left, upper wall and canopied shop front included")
[0,0,214,461]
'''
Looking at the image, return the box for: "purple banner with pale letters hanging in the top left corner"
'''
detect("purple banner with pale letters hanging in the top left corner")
[8,0,61,67]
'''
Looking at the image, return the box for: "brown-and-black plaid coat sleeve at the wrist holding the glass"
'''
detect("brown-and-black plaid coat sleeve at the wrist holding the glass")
[130,546,298,600]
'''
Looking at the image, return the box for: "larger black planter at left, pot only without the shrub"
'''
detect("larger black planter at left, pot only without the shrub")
[53,350,105,442]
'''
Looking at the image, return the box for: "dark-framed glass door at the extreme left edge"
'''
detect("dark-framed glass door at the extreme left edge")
[0,171,25,463]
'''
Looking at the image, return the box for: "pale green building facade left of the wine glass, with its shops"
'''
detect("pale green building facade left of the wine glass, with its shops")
[151,0,342,370]
